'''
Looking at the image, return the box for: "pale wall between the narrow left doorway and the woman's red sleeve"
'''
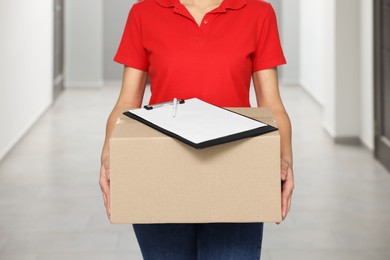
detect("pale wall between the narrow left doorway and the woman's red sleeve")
[65,0,136,87]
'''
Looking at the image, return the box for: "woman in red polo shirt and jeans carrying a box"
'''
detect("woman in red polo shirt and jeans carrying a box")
[100,0,294,260]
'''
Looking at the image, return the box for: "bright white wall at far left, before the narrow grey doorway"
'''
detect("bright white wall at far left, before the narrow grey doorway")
[0,0,53,159]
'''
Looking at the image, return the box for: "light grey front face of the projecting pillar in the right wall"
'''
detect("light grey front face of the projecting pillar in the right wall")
[333,0,361,140]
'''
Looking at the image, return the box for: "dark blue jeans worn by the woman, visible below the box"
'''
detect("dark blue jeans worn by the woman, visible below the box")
[133,223,263,260]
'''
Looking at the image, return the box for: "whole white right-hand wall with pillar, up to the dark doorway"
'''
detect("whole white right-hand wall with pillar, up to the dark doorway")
[300,0,374,146]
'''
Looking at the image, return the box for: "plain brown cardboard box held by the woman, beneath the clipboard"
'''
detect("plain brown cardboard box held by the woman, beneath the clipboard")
[110,108,281,223]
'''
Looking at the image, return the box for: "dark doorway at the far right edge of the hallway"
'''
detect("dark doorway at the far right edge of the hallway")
[374,0,390,171]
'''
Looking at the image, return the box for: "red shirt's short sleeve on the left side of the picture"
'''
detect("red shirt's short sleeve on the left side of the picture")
[114,4,149,71]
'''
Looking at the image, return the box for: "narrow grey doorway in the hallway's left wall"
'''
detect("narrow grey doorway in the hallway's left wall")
[53,0,64,100]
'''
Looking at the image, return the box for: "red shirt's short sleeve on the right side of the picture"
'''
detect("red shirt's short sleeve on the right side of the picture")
[253,4,286,71]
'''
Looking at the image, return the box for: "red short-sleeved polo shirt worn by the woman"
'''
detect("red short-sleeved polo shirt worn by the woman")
[114,0,285,107]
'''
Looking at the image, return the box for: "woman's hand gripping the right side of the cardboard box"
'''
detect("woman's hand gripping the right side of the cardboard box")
[277,159,294,224]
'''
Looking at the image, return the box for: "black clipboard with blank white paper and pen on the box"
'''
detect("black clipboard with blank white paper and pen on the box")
[123,98,278,149]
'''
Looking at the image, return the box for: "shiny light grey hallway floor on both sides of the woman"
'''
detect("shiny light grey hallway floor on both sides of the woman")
[0,84,390,260]
